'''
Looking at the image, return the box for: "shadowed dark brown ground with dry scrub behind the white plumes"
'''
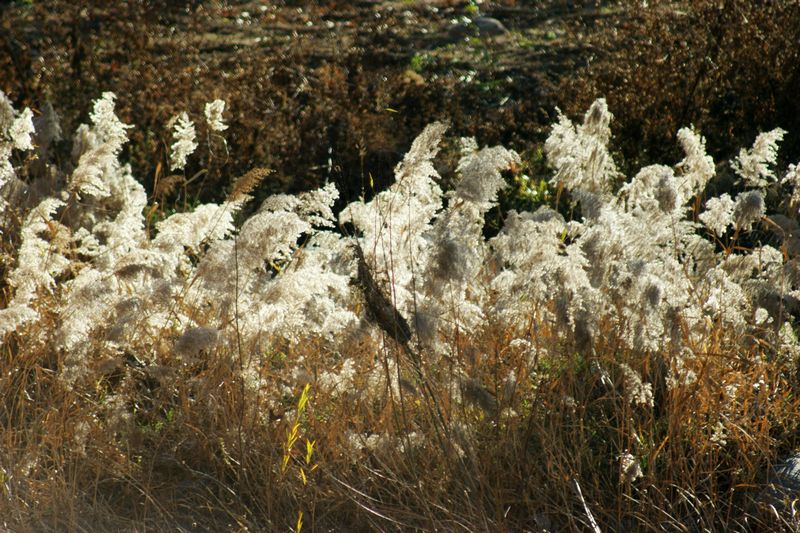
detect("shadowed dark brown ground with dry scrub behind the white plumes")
[0,0,800,209]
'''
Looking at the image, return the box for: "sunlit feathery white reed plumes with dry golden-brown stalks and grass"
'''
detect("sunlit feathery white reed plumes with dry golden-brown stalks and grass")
[0,93,800,531]
